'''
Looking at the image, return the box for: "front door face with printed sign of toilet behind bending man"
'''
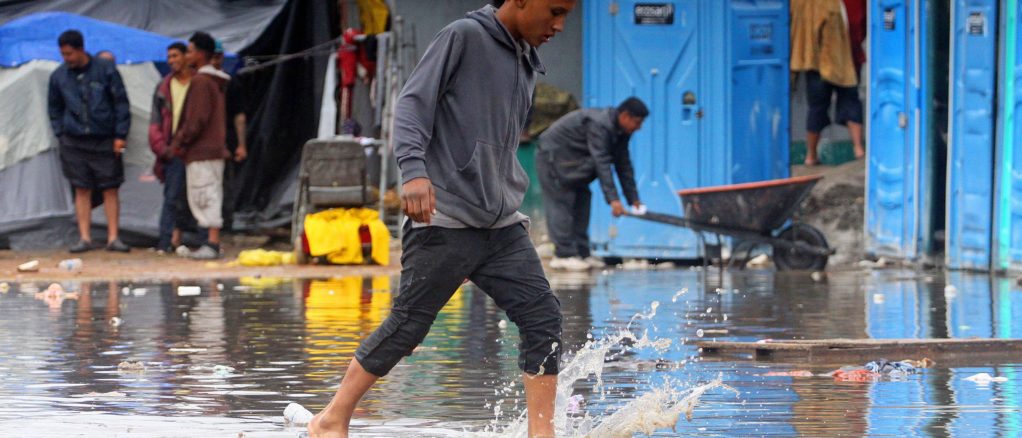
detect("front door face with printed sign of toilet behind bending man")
[583,0,711,258]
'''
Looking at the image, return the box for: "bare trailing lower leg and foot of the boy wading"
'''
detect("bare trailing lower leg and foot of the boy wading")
[309,359,382,438]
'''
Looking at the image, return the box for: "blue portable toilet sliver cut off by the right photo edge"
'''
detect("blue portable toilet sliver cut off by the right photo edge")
[993,0,1022,272]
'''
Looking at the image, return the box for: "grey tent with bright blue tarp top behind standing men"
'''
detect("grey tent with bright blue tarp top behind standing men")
[0,12,174,249]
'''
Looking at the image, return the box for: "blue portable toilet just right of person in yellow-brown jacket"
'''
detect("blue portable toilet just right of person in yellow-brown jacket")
[865,0,948,260]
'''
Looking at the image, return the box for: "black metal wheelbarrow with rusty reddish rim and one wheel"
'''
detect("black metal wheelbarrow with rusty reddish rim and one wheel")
[630,176,834,271]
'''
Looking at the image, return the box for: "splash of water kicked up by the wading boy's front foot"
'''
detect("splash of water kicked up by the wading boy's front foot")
[484,301,738,438]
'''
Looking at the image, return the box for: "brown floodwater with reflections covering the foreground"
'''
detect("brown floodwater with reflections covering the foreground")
[0,269,1022,437]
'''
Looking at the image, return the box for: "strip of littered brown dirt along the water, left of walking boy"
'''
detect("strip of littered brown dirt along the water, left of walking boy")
[0,241,401,283]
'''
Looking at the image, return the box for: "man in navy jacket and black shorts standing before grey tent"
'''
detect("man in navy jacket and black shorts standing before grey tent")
[48,30,131,252]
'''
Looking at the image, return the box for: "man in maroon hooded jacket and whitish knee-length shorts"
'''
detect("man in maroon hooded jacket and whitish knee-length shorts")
[171,32,231,259]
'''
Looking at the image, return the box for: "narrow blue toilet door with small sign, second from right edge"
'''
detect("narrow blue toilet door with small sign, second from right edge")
[944,0,997,271]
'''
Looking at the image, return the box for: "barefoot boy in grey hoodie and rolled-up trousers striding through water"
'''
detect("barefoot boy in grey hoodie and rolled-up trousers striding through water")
[309,0,575,438]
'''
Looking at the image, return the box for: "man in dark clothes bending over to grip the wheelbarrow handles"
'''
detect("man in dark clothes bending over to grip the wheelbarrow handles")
[536,97,649,271]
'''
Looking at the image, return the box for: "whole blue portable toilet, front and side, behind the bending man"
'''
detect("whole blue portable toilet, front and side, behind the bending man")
[583,0,789,258]
